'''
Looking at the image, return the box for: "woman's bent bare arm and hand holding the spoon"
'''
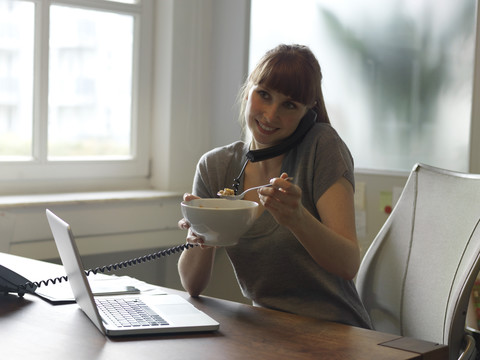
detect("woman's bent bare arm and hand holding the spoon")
[259,174,360,280]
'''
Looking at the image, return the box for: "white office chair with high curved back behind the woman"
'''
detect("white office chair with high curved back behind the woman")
[356,164,480,360]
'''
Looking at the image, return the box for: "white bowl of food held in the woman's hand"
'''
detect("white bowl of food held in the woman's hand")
[181,198,258,246]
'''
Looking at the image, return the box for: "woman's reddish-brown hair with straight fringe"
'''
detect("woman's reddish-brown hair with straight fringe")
[239,44,330,124]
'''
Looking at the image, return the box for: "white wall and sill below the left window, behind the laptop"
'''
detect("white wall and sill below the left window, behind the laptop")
[0,190,185,259]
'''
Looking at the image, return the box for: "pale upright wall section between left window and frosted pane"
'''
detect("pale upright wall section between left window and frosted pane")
[152,0,249,192]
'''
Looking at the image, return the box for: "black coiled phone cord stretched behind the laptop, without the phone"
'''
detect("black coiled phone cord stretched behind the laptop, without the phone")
[18,243,197,294]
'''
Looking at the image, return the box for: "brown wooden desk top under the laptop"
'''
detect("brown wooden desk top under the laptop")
[0,253,448,360]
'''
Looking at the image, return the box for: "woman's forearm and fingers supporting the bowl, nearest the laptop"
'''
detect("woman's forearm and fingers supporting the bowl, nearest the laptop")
[178,194,215,296]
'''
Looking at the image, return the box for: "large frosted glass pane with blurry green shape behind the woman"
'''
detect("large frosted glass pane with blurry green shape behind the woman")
[250,0,476,171]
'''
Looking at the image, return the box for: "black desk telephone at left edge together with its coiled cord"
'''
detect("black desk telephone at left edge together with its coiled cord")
[0,244,196,297]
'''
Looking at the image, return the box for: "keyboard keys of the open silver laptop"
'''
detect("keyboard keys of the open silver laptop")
[95,297,168,328]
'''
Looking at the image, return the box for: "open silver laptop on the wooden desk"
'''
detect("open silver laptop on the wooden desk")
[46,209,219,336]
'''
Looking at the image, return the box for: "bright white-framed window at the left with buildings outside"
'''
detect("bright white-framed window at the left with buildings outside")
[0,0,153,180]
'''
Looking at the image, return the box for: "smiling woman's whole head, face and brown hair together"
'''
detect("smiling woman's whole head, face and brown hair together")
[239,45,330,141]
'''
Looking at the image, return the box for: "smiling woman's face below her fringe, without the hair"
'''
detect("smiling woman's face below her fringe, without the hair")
[245,85,307,149]
